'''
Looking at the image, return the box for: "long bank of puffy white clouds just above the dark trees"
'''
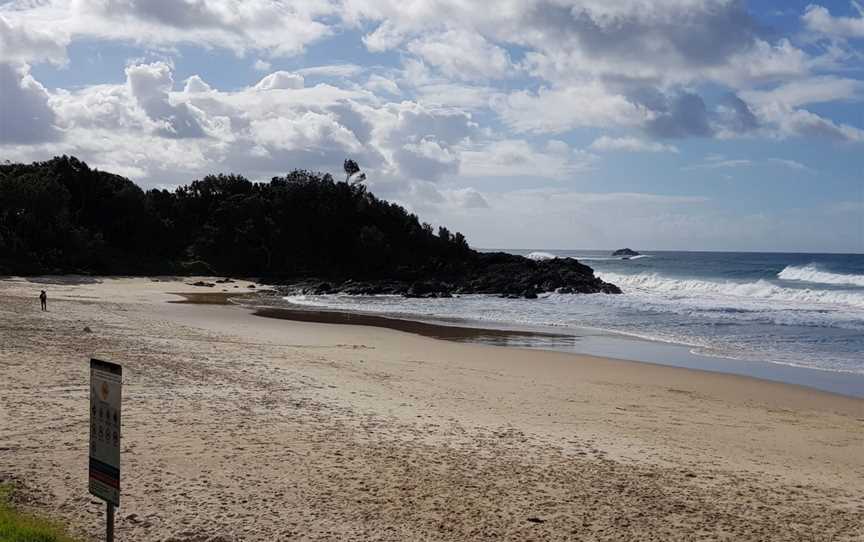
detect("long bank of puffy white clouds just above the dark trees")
[0,62,490,193]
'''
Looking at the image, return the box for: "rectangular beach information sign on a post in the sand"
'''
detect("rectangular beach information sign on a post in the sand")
[89,359,123,542]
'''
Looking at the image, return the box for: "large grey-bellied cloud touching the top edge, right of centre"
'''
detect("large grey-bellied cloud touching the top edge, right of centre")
[344,0,806,91]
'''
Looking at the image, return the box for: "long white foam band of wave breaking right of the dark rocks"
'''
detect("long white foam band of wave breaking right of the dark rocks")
[598,273,864,308]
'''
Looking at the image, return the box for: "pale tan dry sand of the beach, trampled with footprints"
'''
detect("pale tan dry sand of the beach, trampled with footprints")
[0,279,864,542]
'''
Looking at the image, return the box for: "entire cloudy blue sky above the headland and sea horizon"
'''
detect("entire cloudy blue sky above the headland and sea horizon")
[0,0,864,253]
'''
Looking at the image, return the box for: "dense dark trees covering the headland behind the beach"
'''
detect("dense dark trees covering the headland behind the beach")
[0,156,472,278]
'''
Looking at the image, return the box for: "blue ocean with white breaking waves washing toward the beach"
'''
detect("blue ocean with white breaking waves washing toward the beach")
[278,250,864,396]
